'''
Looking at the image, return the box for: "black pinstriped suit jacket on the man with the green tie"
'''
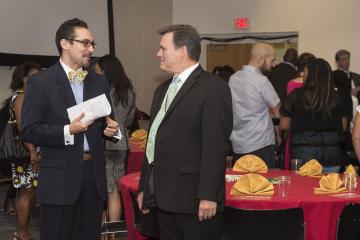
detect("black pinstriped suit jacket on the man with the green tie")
[139,66,232,213]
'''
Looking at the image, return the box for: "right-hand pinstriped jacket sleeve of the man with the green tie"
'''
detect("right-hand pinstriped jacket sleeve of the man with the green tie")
[198,81,233,202]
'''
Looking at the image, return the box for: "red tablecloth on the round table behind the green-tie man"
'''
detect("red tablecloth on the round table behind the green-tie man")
[120,170,360,240]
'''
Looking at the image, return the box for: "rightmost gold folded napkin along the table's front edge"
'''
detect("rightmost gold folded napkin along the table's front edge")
[314,173,346,194]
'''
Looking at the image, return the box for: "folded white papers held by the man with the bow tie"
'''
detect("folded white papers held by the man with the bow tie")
[67,94,111,123]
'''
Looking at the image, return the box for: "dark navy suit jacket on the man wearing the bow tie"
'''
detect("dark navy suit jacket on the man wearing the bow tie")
[21,62,111,204]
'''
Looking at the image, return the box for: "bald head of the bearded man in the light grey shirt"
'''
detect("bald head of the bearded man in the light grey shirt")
[249,43,276,73]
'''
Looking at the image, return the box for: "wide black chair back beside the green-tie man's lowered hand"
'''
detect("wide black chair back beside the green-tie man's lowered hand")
[221,207,305,240]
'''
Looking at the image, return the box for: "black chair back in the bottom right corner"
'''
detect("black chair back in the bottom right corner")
[336,203,360,240]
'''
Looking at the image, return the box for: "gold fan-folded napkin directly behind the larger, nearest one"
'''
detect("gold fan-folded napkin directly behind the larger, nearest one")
[233,154,268,173]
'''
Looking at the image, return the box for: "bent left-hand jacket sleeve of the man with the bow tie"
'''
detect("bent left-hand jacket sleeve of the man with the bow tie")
[21,78,65,147]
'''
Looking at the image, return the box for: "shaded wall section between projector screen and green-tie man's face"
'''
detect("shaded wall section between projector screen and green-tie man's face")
[113,0,172,113]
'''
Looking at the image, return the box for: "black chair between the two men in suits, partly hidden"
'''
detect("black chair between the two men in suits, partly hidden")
[130,191,160,240]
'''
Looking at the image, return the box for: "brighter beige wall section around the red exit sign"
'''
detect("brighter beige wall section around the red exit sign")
[173,0,360,72]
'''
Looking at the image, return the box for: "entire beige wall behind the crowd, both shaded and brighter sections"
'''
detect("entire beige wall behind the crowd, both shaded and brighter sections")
[0,0,360,112]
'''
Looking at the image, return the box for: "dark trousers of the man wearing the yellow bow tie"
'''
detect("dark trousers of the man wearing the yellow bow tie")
[40,160,104,240]
